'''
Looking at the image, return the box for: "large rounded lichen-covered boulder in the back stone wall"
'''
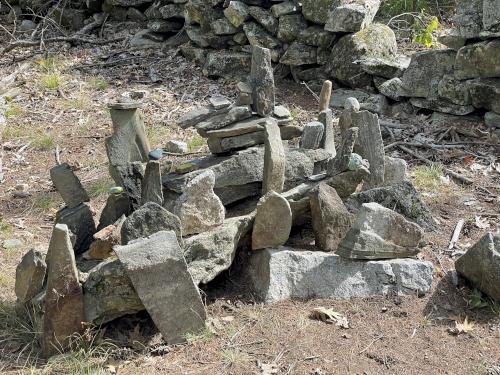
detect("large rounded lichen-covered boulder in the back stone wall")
[328,24,397,87]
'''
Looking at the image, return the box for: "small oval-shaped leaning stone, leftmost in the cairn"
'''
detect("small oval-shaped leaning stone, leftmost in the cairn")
[15,249,47,303]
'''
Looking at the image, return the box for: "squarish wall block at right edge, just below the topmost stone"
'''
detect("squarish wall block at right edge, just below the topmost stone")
[454,39,500,79]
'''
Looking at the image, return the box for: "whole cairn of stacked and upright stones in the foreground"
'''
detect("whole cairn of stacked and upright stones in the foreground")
[16,47,444,356]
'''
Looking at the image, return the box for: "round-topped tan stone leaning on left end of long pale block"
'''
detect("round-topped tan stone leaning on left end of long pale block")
[252,191,292,250]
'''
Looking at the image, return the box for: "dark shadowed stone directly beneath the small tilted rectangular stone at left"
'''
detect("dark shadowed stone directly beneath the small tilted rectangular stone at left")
[56,203,96,255]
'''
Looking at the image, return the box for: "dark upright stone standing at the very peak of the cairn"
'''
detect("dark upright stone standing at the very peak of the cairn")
[250,46,274,117]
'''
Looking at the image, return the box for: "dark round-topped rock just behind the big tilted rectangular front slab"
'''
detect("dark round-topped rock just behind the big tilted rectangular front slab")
[121,202,183,245]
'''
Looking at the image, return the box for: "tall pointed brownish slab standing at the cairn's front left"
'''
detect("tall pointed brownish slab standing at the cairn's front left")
[42,224,85,357]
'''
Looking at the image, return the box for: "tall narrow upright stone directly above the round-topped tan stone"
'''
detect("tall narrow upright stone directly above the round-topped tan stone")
[262,118,286,194]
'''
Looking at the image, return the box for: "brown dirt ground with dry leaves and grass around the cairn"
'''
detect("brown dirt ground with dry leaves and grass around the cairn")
[0,27,500,375]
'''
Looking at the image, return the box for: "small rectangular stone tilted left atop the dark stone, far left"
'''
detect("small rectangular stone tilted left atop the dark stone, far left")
[50,163,90,208]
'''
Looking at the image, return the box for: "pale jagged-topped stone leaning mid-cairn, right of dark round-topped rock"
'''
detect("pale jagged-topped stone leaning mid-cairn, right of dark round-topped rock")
[174,170,226,236]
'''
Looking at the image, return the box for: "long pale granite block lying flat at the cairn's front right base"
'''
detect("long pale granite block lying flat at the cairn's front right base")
[248,247,433,303]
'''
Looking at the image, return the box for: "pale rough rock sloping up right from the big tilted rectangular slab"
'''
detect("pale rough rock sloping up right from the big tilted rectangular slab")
[184,216,252,284]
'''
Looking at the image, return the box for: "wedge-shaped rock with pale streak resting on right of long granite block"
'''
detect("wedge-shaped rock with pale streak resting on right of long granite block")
[337,203,423,259]
